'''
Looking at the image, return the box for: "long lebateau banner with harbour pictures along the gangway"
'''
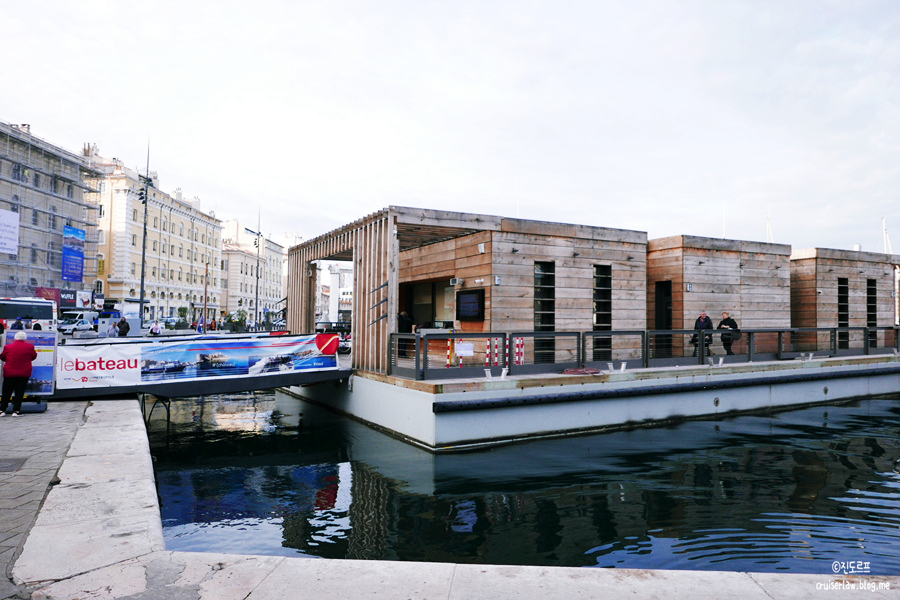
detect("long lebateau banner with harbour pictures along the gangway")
[56,334,338,389]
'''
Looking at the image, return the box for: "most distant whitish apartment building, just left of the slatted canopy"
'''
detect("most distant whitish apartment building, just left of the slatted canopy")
[222,220,285,324]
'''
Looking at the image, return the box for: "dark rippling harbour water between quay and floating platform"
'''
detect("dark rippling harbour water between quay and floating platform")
[151,394,900,575]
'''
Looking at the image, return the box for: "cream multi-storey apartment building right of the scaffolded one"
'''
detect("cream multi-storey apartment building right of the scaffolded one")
[85,146,222,322]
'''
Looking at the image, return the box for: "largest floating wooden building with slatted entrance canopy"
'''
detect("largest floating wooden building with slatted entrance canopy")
[288,206,647,373]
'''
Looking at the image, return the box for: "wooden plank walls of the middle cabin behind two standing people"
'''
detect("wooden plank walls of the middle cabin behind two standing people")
[646,236,791,329]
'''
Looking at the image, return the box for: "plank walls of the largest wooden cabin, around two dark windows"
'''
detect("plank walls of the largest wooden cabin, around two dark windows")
[399,219,647,331]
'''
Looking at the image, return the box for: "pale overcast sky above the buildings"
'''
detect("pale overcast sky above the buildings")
[0,0,900,253]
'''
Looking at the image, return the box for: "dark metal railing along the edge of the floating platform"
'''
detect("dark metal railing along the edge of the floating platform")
[389,326,900,380]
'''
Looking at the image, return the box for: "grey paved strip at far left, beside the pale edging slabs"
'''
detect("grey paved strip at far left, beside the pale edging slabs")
[0,402,87,599]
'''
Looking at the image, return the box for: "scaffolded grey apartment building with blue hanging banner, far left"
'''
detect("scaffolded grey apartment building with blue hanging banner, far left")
[0,122,98,302]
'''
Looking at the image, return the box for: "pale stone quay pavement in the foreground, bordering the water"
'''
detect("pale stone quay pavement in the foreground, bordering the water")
[0,400,900,600]
